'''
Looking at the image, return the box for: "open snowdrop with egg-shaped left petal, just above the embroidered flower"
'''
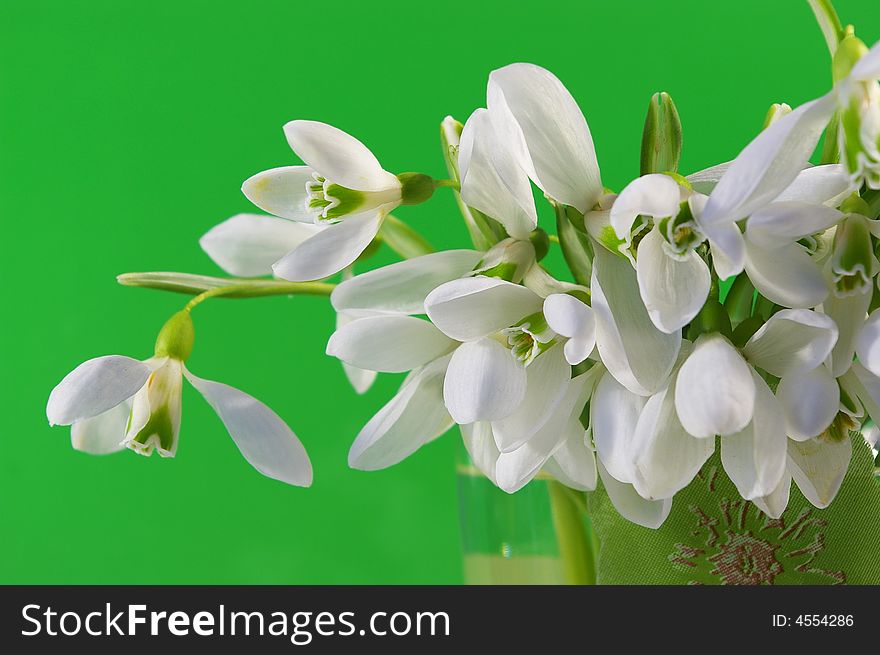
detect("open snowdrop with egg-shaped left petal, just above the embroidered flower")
[675,309,840,500]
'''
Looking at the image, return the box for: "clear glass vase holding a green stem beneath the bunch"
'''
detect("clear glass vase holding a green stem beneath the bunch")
[457,445,596,585]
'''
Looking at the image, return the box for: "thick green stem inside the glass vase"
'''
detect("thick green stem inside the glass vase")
[547,480,596,585]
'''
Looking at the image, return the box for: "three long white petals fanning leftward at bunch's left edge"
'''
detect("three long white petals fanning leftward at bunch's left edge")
[328,243,540,469]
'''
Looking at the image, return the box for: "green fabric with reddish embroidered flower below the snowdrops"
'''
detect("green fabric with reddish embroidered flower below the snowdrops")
[589,434,880,585]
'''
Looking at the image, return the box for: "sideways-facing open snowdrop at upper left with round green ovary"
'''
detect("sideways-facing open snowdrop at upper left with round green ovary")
[242,120,434,281]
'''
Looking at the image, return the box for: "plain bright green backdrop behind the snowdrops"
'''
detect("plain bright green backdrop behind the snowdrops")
[0,0,880,583]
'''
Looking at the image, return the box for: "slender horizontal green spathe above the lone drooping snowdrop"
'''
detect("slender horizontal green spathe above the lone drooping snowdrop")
[116,272,336,307]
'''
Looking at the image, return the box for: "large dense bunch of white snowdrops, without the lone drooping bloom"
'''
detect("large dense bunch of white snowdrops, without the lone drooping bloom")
[46,23,880,527]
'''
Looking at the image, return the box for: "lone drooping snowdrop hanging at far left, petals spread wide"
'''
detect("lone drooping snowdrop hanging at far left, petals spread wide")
[46,311,312,487]
